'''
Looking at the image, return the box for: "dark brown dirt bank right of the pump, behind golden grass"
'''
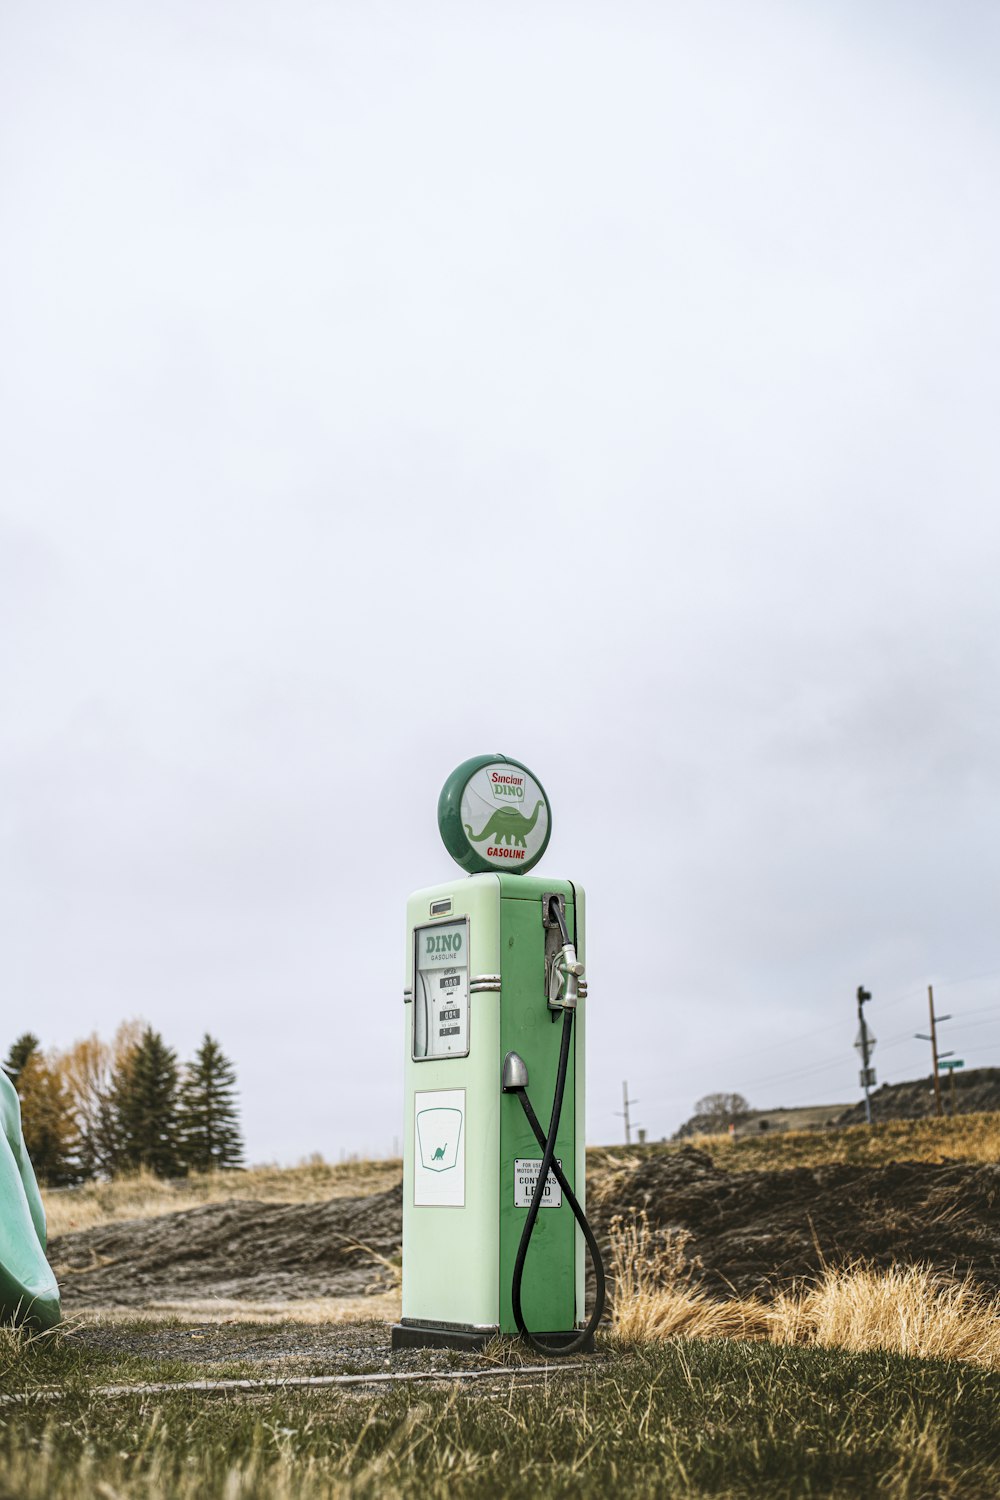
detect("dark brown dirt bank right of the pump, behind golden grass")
[592,1146,1000,1296]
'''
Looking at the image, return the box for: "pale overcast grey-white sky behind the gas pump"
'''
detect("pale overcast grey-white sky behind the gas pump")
[0,0,1000,1161]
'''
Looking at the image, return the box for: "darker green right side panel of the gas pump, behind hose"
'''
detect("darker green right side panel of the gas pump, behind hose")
[499,876,577,1334]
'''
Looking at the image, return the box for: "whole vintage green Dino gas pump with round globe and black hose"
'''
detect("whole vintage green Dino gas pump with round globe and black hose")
[393,755,604,1353]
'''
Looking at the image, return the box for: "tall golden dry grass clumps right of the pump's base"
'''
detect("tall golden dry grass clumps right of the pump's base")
[612,1214,1000,1370]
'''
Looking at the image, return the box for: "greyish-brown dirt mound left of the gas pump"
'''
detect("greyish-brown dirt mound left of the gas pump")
[49,1188,402,1310]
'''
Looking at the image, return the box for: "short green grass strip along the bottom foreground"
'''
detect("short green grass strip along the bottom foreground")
[0,1340,1000,1500]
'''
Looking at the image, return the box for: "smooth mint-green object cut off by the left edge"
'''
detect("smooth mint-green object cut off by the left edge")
[0,1073,61,1328]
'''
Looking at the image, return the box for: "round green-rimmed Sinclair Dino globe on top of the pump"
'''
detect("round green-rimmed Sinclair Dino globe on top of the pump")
[438,755,552,875]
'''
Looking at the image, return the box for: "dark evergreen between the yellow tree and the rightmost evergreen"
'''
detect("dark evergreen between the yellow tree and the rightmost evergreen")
[111,1026,183,1178]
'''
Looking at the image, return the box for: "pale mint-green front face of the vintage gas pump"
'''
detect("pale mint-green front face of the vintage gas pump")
[403,872,501,1328]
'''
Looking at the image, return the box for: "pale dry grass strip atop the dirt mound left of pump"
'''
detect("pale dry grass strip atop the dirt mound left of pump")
[42,1157,403,1238]
